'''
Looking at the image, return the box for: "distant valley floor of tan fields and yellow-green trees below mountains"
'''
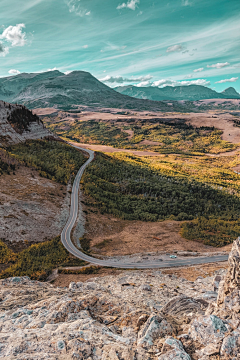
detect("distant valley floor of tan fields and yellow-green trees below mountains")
[39,109,240,155]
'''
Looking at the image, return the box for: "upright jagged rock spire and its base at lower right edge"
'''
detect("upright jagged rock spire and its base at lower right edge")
[188,238,240,360]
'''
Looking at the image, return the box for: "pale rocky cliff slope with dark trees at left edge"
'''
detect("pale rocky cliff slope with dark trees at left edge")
[0,101,52,146]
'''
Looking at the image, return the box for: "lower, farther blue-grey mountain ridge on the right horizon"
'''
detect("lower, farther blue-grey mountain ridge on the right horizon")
[115,85,240,101]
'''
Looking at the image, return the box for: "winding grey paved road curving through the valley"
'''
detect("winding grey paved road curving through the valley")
[61,144,228,269]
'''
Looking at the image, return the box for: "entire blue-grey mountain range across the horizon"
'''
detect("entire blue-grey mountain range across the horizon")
[0,70,240,110]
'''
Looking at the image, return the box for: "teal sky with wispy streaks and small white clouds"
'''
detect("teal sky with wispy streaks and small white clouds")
[0,0,240,92]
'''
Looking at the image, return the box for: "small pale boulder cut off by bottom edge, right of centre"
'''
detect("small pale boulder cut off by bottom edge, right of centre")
[158,337,191,360]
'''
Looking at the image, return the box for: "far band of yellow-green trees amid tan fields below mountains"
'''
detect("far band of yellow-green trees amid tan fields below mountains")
[44,118,237,154]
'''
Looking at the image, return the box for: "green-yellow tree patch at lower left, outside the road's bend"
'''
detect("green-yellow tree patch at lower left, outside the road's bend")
[0,236,85,280]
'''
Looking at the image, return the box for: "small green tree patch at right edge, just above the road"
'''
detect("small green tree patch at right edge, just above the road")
[181,217,240,247]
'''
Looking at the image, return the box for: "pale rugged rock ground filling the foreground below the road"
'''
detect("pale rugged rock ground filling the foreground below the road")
[0,238,240,360]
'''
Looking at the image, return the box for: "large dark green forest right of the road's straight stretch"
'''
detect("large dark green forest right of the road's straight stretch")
[82,153,240,221]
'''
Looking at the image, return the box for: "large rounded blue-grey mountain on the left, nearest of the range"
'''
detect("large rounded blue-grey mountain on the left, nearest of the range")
[0,71,182,110]
